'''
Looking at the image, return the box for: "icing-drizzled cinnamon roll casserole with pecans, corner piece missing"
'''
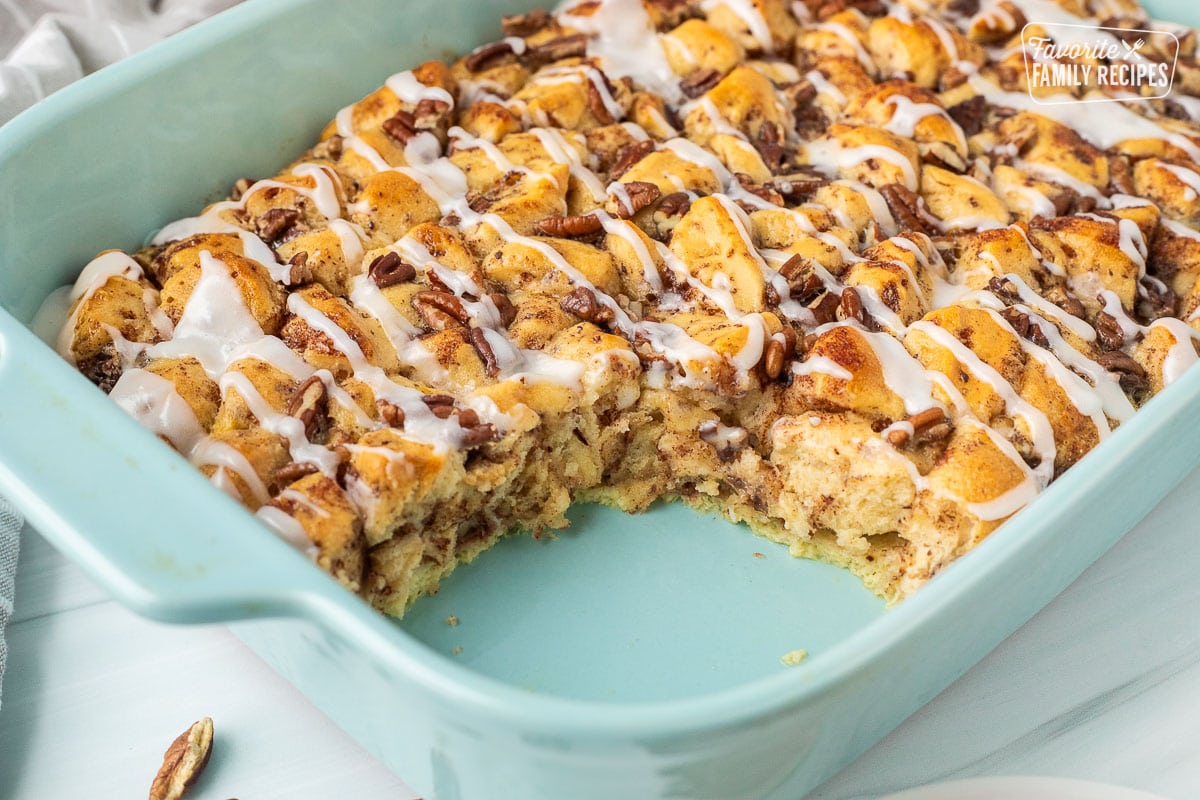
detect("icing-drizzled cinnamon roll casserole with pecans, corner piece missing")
[51,0,1200,615]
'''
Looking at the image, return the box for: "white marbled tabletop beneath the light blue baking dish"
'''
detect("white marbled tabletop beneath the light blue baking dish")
[0,473,1200,800]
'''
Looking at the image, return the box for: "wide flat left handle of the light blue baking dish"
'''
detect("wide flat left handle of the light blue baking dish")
[0,308,344,622]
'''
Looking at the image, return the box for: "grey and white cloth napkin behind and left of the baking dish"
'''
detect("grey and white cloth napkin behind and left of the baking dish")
[0,0,239,710]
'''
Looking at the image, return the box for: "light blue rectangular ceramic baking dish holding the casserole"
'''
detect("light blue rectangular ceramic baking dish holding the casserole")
[0,0,1200,800]
